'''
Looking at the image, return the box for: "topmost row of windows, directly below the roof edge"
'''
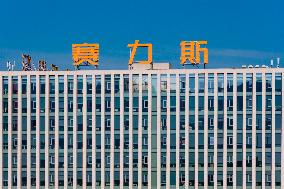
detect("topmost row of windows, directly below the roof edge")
[2,73,282,94]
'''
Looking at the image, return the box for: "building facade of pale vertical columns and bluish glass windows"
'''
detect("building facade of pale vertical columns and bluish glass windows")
[0,68,284,188]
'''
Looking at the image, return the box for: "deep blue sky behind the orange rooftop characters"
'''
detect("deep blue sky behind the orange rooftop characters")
[0,0,284,70]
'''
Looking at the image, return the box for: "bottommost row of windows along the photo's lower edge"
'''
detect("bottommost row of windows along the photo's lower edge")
[3,171,281,187]
